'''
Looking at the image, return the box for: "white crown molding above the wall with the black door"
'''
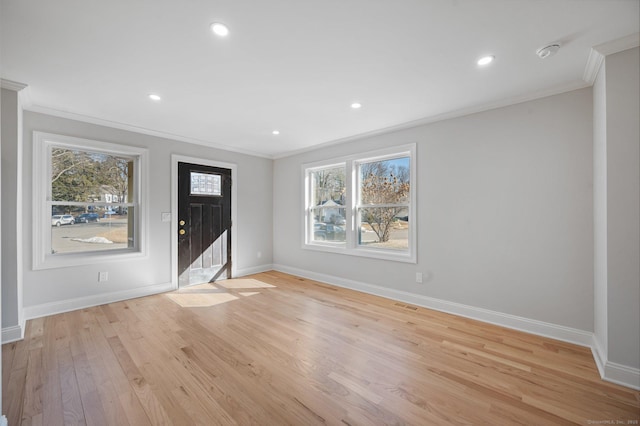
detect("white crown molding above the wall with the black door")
[24,104,272,160]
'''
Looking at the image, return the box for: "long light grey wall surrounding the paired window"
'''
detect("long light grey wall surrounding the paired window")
[274,88,593,332]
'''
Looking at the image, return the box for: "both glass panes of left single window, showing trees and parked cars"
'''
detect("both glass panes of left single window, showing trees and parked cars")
[50,146,135,253]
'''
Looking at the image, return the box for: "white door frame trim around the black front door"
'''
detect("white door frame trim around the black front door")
[171,154,238,290]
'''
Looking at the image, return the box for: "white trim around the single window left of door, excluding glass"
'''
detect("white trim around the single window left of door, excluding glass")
[31,131,149,270]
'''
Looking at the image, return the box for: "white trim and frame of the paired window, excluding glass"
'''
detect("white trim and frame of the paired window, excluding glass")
[302,143,418,263]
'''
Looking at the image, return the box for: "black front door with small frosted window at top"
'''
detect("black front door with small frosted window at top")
[177,163,231,287]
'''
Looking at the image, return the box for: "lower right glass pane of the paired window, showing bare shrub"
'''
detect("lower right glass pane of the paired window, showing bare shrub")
[358,207,409,250]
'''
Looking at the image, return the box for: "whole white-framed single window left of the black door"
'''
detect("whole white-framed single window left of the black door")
[33,132,146,269]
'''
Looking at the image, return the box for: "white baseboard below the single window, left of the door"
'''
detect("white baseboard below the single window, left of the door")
[24,283,175,320]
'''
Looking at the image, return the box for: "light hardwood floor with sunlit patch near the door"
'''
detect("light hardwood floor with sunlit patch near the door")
[2,272,640,426]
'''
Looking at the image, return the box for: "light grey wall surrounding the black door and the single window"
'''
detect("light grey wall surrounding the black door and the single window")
[3,111,273,327]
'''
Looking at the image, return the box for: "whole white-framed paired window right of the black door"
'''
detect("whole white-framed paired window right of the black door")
[303,145,416,263]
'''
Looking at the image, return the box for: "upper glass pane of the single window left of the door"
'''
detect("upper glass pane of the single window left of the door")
[51,146,133,203]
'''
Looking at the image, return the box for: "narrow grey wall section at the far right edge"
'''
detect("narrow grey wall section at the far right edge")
[605,48,640,372]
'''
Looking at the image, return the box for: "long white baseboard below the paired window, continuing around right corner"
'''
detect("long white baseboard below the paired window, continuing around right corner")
[273,264,640,390]
